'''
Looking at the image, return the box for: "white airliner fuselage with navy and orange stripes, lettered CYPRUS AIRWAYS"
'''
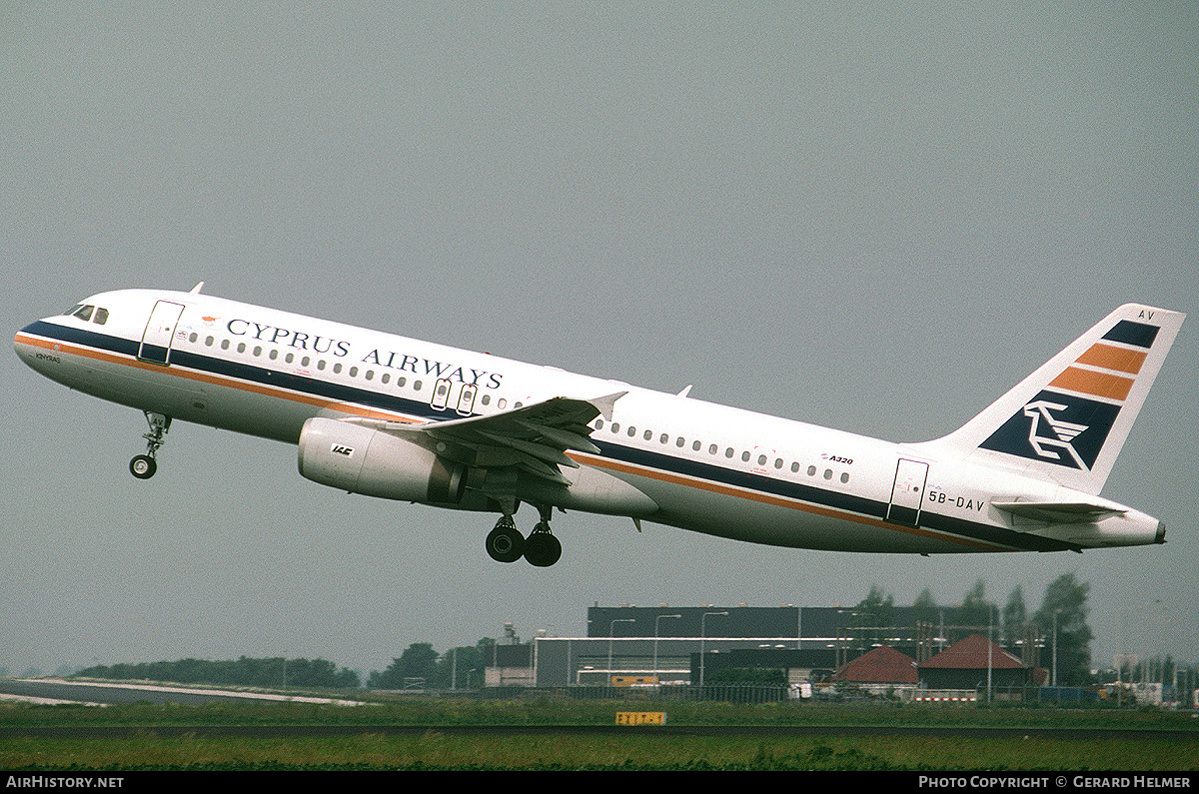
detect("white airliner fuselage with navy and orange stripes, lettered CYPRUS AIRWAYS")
[14,290,1161,553]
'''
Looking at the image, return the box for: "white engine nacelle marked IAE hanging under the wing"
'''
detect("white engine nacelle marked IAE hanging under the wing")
[300,417,466,505]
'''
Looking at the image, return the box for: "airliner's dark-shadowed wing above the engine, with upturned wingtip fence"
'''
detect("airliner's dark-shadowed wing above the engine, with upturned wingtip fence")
[345,391,628,486]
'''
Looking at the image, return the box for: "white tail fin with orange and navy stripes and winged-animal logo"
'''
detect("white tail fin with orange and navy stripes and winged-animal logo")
[932,303,1186,494]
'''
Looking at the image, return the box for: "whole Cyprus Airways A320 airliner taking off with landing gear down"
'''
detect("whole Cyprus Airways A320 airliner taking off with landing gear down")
[13,284,1186,566]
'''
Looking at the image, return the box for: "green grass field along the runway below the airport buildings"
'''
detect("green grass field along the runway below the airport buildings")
[0,698,1199,771]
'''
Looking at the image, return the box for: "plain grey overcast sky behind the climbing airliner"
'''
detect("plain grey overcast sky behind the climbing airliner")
[7,0,1199,672]
